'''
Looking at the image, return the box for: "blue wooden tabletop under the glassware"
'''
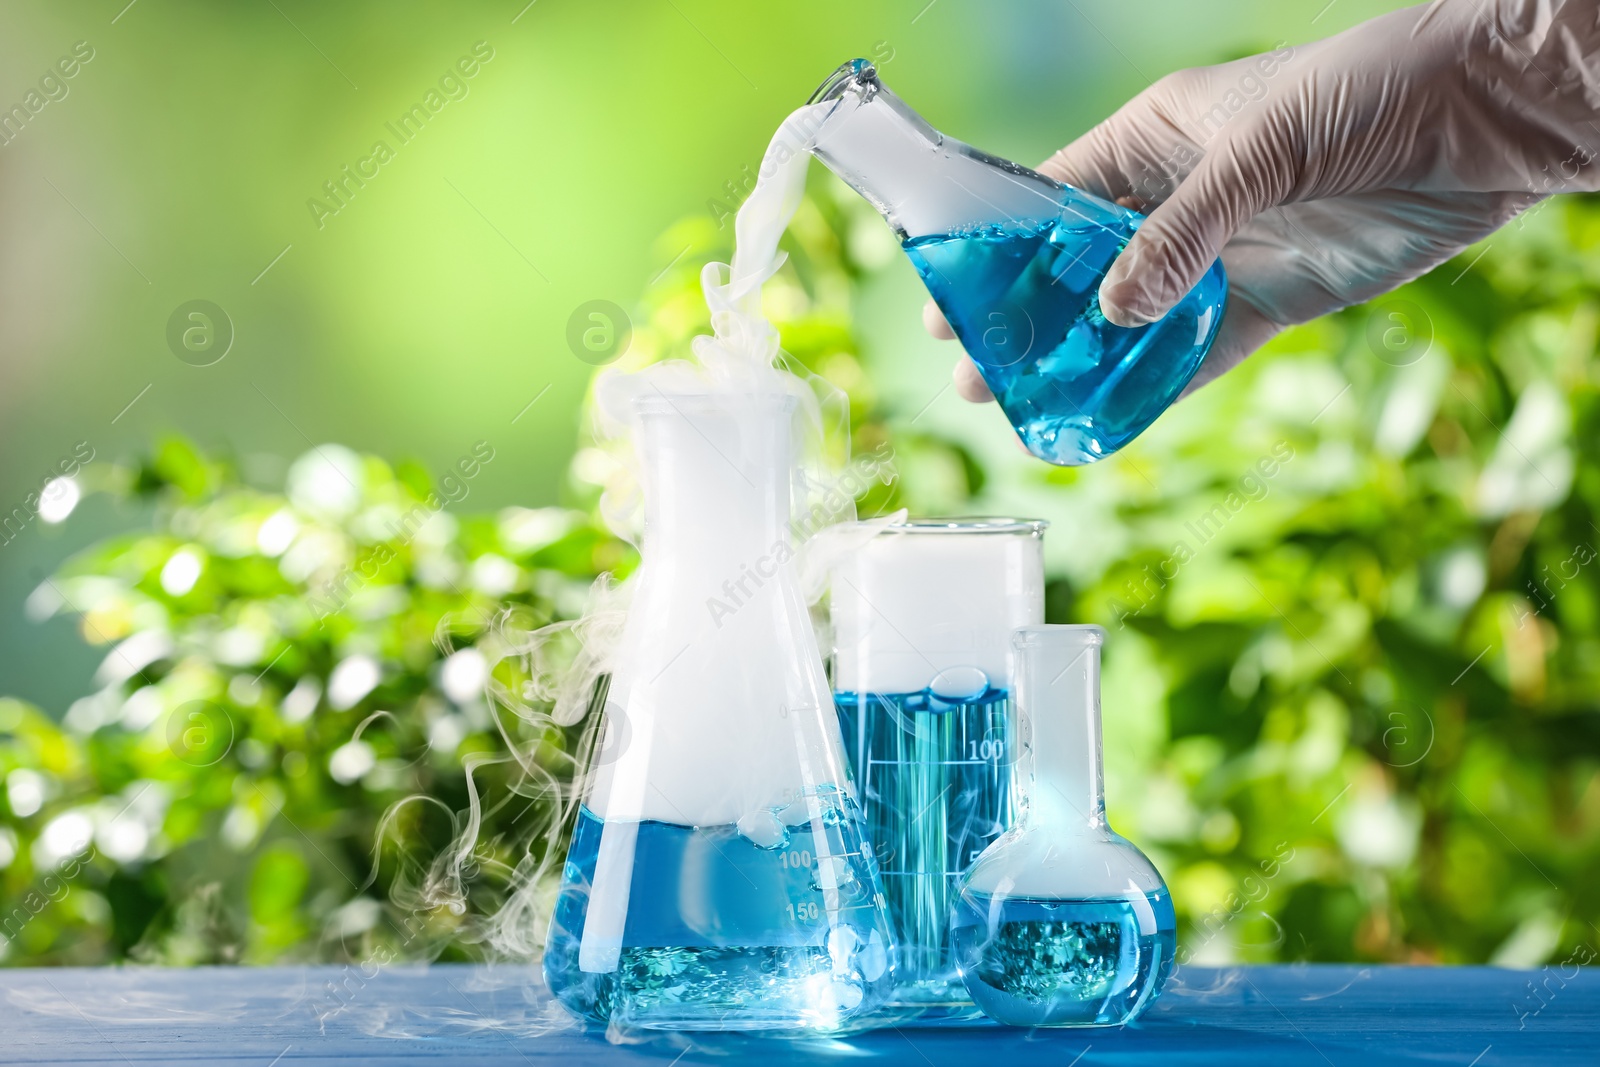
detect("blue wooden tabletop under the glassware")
[0,966,1600,1067]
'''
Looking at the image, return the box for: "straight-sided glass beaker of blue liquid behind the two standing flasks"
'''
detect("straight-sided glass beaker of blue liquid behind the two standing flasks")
[830,518,1046,1022]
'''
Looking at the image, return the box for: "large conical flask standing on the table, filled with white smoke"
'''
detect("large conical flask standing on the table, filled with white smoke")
[544,392,893,1030]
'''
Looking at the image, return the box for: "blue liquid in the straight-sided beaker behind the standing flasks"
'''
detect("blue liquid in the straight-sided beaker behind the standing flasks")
[834,688,1013,1014]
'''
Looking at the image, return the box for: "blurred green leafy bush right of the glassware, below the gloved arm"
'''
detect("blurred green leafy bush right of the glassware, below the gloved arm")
[1081,197,1600,966]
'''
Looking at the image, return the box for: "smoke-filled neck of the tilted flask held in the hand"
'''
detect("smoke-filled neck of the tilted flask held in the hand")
[810,59,1064,242]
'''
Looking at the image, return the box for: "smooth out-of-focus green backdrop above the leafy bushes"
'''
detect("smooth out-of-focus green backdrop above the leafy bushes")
[0,0,1410,709]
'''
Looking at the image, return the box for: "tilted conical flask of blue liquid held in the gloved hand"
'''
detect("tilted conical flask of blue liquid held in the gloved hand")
[811,59,1227,466]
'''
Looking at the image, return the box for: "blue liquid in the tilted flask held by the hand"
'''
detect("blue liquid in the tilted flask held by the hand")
[904,212,1227,464]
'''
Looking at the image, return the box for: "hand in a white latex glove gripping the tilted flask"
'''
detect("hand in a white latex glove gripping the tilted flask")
[923,0,1600,400]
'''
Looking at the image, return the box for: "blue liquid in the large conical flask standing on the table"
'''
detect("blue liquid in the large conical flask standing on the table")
[544,787,893,1030]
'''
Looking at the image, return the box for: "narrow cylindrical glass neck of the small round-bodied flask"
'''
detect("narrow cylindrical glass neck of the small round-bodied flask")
[1011,625,1106,832]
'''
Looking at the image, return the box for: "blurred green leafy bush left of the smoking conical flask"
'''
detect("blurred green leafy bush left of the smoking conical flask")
[0,428,630,963]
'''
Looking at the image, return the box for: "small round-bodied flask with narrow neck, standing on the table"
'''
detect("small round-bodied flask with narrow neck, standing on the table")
[950,625,1178,1027]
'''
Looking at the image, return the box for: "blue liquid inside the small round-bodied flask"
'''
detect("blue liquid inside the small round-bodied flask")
[950,891,1178,1027]
